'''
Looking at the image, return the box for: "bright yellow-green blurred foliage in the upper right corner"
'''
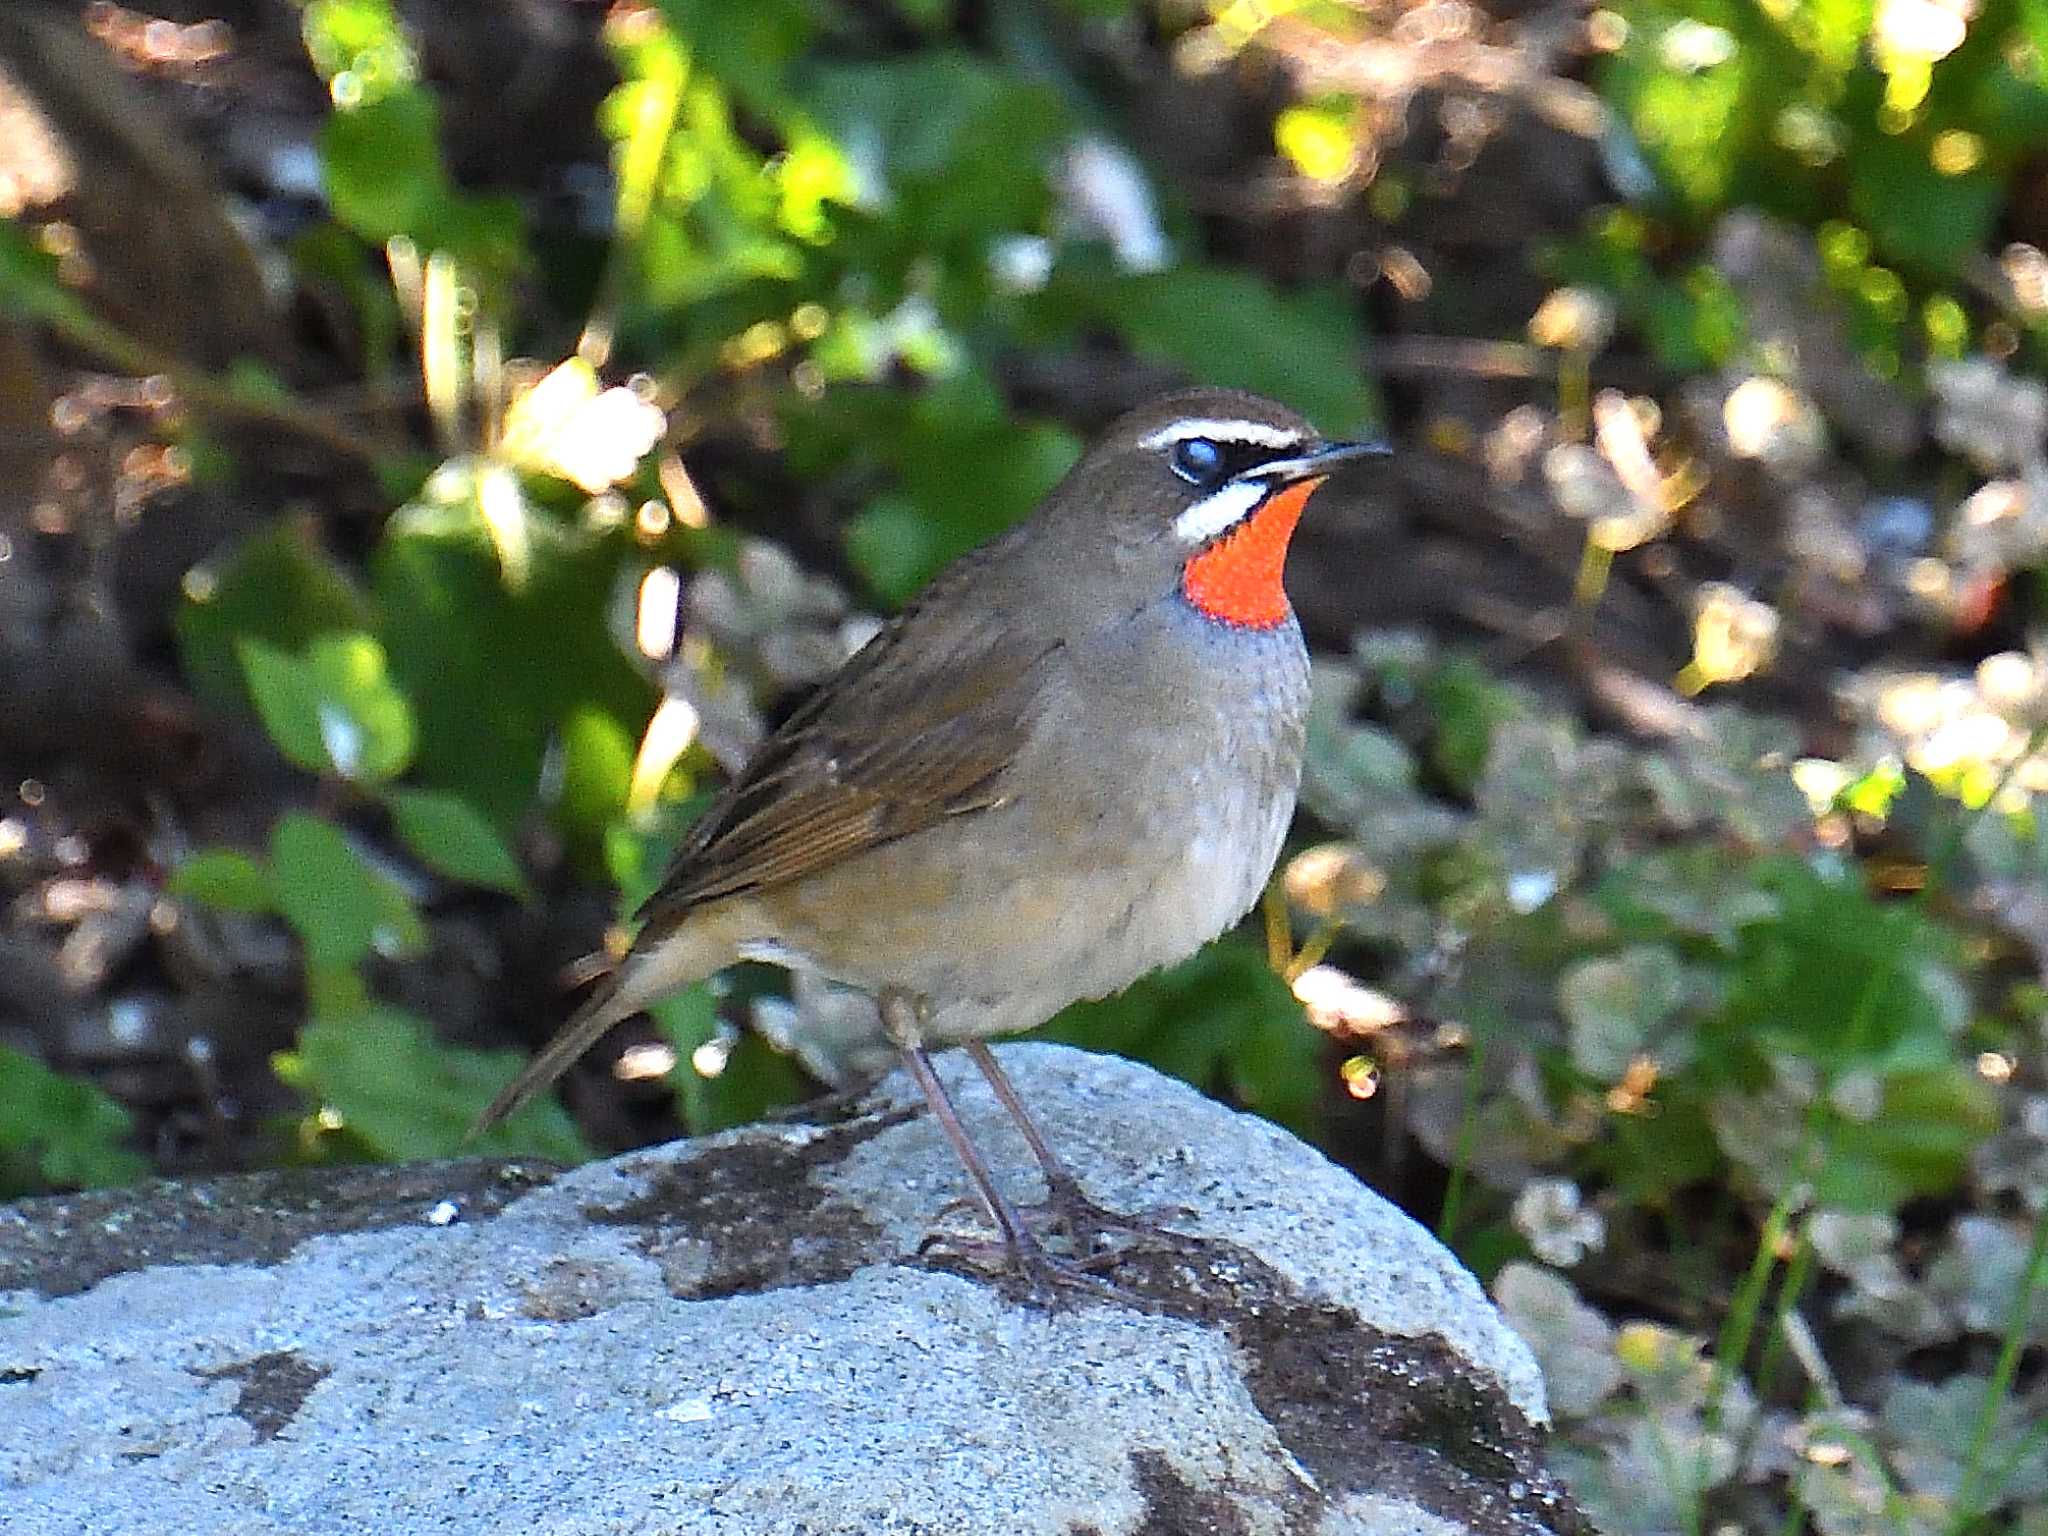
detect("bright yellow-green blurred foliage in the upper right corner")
[1552,0,2048,379]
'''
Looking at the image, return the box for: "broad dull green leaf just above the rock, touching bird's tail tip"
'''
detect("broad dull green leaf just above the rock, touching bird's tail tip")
[274,1008,590,1163]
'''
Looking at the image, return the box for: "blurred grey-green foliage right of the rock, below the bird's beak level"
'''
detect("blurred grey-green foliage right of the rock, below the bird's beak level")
[1286,635,2048,1536]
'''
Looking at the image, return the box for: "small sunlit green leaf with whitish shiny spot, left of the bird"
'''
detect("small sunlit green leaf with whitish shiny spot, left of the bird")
[238,635,414,784]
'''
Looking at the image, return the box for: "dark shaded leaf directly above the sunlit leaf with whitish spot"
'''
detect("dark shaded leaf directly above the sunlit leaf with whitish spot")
[176,518,369,709]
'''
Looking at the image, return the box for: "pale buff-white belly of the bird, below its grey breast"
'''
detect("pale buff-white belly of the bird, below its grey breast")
[741,602,1305,1044]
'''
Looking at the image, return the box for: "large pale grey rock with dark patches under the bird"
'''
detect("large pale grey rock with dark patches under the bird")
[0,1047,1585,1536]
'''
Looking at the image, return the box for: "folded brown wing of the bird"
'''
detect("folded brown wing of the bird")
[641,552,1061,932]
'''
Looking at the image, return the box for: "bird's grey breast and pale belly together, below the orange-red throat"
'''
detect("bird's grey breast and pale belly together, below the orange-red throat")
[760,606,1309,1040]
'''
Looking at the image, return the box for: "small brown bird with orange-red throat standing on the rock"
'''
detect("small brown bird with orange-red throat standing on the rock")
[479,389,1384,1284]
